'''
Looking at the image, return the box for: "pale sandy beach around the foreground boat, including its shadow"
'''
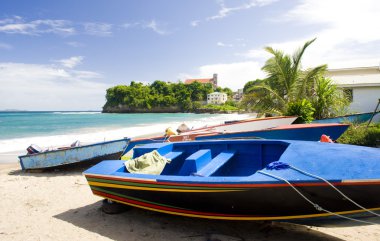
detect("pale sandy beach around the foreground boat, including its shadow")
[0,163,380,241]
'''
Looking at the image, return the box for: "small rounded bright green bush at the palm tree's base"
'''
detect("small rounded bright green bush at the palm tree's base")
[285,99,315,123]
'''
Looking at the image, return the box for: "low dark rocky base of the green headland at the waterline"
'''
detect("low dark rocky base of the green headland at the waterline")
[103,105,183,113]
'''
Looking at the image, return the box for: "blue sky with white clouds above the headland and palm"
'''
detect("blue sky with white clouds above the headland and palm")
[0,0,380,110]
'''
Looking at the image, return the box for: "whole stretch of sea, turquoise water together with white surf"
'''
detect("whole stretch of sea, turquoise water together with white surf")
[0,111,248,162]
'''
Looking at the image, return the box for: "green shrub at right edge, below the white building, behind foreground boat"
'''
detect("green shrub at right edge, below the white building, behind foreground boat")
[337,124,380,147]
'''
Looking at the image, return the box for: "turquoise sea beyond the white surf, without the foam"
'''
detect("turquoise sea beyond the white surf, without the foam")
[0,112,218,140]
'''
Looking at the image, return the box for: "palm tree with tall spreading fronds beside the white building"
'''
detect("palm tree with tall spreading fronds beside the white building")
[245,39,327,114]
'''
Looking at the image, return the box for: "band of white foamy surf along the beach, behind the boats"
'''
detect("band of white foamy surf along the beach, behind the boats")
[0,111,254,163]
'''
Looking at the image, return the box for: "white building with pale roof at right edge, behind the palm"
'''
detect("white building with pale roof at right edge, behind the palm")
[326,66,380,113]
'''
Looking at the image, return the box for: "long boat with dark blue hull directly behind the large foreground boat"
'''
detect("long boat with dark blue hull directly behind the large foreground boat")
[167,123,350,142]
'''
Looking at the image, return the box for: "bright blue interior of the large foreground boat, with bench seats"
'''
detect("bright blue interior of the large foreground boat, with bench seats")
[124,140,289,177]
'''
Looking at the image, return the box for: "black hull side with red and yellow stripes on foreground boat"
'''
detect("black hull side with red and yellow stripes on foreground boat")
[86,166,380,220]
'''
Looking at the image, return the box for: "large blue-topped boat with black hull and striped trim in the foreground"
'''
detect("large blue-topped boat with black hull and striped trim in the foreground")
[84,140,380,222]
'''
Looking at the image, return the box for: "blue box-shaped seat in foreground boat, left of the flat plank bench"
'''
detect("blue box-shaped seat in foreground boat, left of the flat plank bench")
[178,149,211,176]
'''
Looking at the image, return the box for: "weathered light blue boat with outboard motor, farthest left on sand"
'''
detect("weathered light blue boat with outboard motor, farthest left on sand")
[19,138,130,170]
